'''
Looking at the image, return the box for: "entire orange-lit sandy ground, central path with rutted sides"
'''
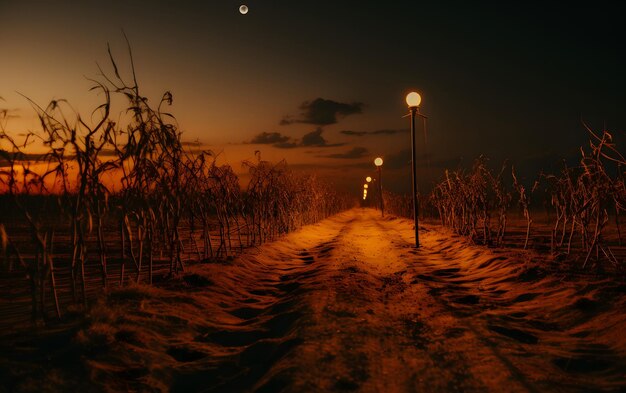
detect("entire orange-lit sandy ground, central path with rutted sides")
[0,209,626,392]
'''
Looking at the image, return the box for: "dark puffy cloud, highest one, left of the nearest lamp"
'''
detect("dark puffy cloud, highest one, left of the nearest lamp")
[280,98,363,126]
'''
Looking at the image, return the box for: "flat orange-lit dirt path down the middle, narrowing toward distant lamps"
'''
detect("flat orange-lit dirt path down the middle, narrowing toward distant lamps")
[264,211,536,392]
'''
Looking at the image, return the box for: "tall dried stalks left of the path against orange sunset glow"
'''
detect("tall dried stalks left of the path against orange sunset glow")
[0,43,350,321]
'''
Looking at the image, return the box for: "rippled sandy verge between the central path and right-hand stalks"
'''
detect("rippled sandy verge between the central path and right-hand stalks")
[370,214,626,392]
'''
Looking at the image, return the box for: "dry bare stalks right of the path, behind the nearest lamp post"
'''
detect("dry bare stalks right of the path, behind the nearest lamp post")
[385,127,626,267]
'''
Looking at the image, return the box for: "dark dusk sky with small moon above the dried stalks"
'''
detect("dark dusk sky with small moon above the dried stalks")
[0,0,626,192]
